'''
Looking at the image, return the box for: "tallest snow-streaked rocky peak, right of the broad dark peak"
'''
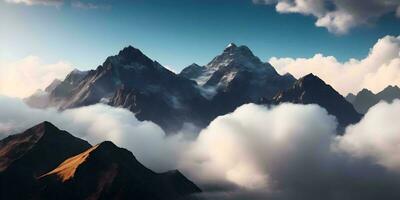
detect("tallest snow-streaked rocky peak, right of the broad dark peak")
[179,43,296,117]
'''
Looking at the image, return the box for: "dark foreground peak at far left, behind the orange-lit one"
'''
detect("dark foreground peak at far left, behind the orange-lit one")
[0,122,91,199]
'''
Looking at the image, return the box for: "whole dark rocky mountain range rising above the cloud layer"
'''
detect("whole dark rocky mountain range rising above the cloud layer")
[26,43,361,134]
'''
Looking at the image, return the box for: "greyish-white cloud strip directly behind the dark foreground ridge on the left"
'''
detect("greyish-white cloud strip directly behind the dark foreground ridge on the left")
[0,95,190,171]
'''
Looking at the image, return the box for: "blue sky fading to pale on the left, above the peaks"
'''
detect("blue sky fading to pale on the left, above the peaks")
[0,0,400,71]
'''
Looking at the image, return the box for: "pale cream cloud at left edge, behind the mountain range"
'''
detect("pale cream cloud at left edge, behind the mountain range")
[0,56,73,97]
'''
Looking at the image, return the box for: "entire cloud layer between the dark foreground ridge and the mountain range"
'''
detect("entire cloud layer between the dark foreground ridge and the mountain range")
[0,96,400,200]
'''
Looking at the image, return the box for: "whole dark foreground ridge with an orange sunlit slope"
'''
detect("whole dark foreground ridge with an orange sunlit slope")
[0,122,201,200]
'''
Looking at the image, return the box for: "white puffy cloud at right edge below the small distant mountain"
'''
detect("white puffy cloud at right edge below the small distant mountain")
[339,100,400,172]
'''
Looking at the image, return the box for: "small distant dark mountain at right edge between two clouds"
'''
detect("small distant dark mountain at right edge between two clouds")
[346,86,400,114]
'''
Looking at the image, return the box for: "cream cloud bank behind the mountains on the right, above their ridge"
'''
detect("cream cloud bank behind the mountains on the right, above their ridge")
[269,36,400,95]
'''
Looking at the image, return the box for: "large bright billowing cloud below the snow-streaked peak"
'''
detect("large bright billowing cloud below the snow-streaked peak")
[181,104,336,189]
